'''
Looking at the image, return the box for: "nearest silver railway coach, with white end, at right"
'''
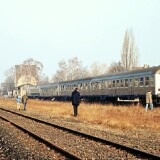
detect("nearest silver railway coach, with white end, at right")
[91,66,160,104]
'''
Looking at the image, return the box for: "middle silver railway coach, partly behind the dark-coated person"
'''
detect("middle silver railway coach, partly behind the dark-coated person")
[39,78,91,101]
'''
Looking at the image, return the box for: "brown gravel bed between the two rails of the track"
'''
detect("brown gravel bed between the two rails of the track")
[1,111,142,160]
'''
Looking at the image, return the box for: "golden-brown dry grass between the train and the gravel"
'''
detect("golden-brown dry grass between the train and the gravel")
[0,99,160,131]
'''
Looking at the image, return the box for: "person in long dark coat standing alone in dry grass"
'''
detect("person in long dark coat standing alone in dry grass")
[71,87,80,117]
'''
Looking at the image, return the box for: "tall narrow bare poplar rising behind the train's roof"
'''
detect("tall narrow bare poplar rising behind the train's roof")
[121,30,138,70]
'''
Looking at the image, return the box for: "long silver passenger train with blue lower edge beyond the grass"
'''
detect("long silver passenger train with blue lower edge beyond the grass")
[27,66,160,104]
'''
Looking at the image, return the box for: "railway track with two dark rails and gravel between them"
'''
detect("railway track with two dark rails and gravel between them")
[0,108,160,159]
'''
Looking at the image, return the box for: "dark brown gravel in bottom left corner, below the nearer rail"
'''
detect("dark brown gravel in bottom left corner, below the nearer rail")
[0,119,66,160]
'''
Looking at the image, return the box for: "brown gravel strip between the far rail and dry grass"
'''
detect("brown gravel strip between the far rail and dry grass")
[32,116,160,156]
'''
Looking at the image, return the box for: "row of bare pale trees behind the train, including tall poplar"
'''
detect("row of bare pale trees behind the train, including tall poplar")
[0,29,139,94]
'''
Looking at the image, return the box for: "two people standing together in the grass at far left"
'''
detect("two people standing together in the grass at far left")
[16,94,28,110]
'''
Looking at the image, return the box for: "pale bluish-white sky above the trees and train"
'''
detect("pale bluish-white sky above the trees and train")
[0,0,160,82]
